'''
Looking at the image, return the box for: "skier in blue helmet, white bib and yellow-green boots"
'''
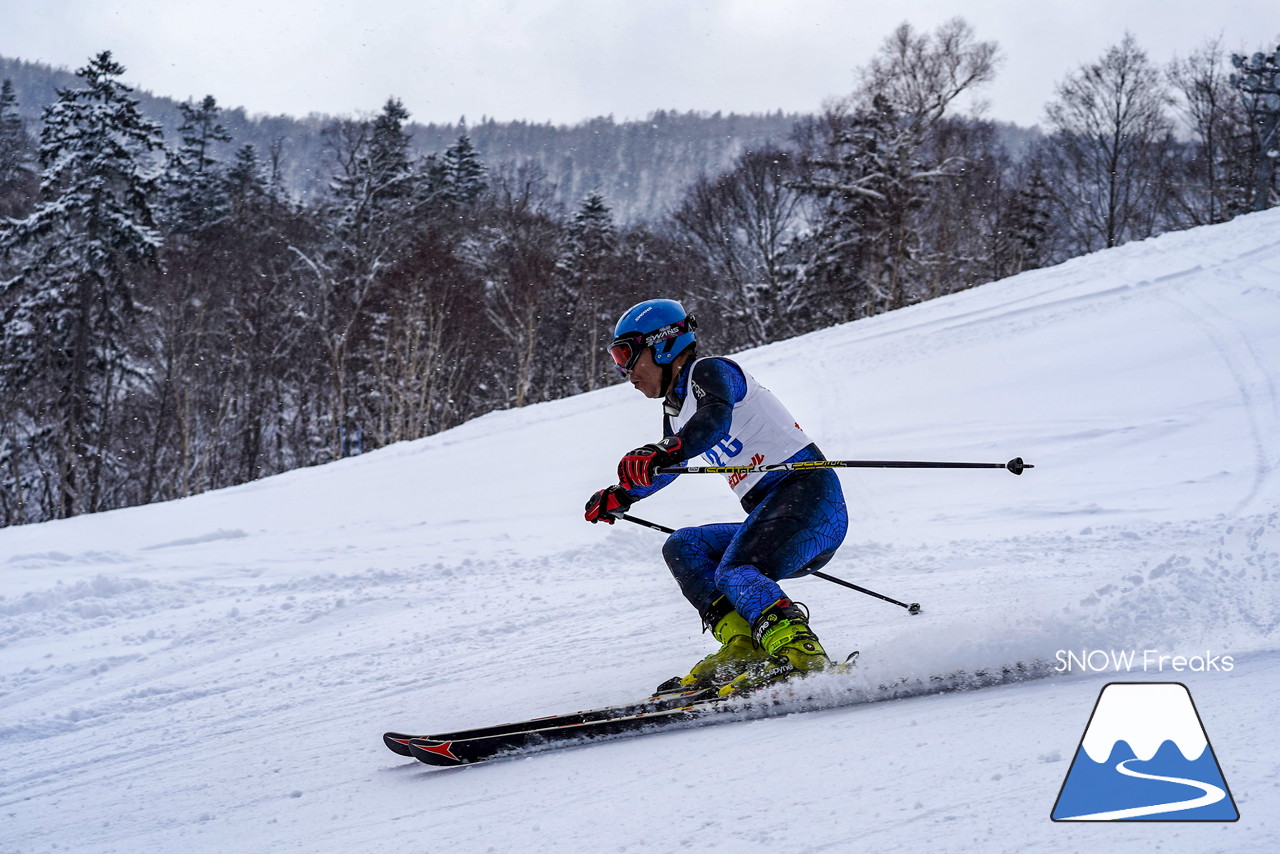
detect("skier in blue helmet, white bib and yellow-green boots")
[586,300,849,695]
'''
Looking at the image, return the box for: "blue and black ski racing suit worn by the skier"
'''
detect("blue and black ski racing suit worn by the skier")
[627,357,849,624]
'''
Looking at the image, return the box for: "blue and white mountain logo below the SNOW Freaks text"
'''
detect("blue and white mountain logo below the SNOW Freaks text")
[1051,682,1240,822]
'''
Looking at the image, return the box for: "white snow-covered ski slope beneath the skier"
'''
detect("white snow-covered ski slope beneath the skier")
[0,210,1280,853]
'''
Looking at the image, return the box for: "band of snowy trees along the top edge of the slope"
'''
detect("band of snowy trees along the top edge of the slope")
[0,19,1280,525]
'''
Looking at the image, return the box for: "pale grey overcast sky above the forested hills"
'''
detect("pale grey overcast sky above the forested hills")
[0,0,1280,125]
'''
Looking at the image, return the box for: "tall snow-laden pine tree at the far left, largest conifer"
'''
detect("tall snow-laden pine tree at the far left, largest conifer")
[0,51,163,516]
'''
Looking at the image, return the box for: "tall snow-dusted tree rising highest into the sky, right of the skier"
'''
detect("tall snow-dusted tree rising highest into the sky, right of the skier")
[796,19,997,320]
